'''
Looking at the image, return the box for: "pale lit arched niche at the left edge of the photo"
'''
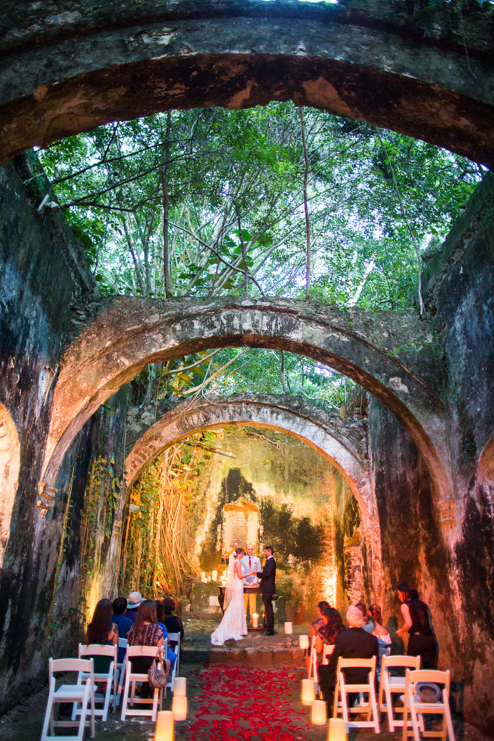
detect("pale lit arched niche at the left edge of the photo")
[0,404,20,570]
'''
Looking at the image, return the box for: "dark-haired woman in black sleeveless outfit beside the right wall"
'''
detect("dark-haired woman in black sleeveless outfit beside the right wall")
[396,584,437,669]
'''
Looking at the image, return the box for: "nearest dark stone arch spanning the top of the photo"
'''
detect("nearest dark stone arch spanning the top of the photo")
[0,0,494,167]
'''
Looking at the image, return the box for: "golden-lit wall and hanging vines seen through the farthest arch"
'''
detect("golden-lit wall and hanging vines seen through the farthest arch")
[122,424,370,623]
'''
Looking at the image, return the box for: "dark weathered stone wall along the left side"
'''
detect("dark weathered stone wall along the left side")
[0,158,96,708]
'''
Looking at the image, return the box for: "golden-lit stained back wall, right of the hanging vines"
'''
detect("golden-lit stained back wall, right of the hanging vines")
[181,427,368,622]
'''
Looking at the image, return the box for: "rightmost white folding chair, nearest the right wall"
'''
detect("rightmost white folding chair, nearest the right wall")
[403,669,455,741]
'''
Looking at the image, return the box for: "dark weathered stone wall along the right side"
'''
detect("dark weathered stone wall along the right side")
[369,175,494,734]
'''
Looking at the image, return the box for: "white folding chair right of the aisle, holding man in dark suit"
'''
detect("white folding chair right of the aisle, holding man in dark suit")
[333,656,379,733]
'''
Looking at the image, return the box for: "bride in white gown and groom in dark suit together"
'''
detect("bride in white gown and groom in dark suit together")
[211,546,276,646]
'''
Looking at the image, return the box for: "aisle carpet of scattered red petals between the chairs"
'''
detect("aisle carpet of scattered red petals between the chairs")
[182,666,310,741]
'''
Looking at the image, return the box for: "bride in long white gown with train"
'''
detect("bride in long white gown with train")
[211,548,256,646]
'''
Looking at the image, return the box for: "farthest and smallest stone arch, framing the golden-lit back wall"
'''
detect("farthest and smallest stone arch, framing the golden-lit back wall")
[125,393,384,598]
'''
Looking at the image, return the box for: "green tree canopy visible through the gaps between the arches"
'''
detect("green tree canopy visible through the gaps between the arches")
[39,103,483,406]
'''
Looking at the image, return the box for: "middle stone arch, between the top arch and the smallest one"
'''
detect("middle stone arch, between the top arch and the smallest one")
[42,297,450,497]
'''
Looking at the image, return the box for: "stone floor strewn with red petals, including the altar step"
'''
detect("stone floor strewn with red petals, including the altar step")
[0,621,488,741]
